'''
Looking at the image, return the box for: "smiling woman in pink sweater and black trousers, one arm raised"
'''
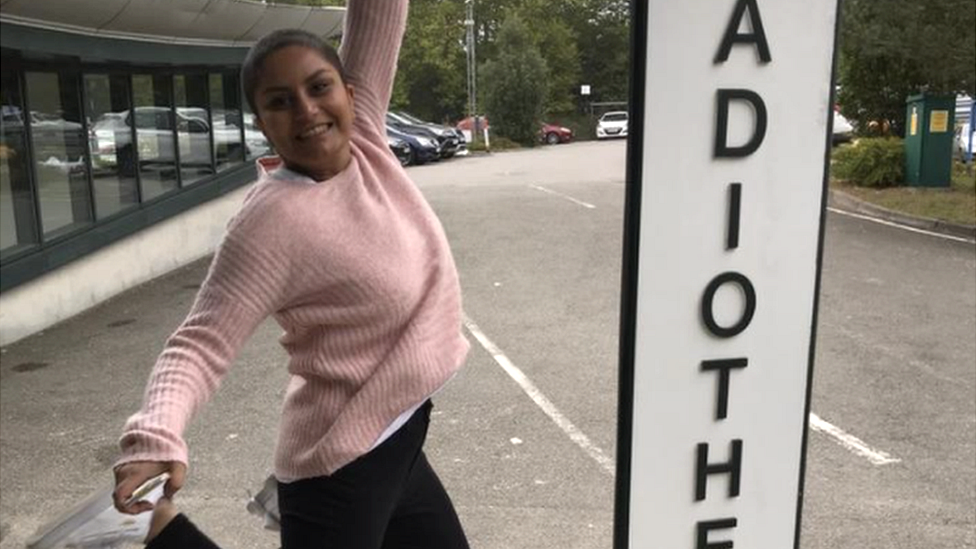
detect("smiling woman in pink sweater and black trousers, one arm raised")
[114,0,469,549]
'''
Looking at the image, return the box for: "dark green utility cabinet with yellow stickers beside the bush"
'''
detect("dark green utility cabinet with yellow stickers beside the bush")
[905,93,956,187]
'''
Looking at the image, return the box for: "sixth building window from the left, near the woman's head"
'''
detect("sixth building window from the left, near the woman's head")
[210,73,244,171]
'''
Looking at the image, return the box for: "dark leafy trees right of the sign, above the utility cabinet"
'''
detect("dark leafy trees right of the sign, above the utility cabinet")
[838,0,976,136]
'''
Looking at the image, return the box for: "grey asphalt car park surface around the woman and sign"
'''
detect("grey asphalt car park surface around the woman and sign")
[0,141,976,549]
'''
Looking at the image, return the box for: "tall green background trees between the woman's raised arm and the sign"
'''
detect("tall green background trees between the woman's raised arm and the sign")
[274,0,630,123]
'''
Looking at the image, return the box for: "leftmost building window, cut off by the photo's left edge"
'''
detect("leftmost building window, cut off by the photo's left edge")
[0,67,37,258]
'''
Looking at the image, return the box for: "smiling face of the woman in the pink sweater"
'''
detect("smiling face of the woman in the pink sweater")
[254,46,354,181]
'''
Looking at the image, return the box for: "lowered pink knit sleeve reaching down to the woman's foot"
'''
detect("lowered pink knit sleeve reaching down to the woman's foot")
[118,192,291,464]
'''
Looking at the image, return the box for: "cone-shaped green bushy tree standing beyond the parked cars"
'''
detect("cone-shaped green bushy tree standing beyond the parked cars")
[482,14,549,145]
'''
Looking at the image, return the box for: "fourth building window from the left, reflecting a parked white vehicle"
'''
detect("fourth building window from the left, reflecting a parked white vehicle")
[132,74,179,201]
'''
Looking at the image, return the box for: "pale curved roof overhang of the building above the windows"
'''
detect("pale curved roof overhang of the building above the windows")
[0,0,345,47]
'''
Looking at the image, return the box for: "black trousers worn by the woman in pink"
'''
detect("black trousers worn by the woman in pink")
[148,402,469,549]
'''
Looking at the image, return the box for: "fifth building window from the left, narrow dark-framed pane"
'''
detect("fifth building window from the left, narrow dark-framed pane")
[173,74,214,185]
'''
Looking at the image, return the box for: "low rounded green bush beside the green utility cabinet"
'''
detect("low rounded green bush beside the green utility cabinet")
[831,137,905,187]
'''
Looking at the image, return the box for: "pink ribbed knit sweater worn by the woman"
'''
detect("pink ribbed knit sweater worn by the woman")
[119,0,469,481]
